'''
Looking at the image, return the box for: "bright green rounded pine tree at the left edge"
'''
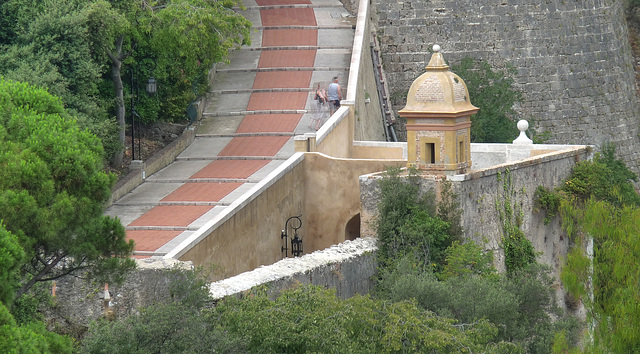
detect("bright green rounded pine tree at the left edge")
[0,79,134,296]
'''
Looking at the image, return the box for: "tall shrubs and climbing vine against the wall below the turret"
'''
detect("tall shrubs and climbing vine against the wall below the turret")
[377,171,577,353]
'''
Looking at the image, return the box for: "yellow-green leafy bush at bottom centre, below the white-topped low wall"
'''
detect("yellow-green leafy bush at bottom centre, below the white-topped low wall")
[213,286,516,353]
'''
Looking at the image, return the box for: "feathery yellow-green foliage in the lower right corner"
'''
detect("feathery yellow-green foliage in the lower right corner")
[562,199,640,353]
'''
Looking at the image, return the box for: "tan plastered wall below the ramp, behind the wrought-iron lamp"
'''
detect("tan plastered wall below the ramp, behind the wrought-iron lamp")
[180,153,406,281]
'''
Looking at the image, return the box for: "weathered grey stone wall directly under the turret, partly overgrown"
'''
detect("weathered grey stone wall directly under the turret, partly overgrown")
[360,144,593,303]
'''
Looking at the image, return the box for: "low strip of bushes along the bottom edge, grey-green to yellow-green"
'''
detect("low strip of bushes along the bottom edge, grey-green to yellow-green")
[82,276,517,353]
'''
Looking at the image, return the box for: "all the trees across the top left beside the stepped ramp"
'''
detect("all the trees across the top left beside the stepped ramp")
[0,0,251,167]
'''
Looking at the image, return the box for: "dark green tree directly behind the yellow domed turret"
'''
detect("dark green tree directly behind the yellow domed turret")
[452,57,522,143]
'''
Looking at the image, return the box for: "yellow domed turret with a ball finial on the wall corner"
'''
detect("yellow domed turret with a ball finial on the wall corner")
[398,45,478,174]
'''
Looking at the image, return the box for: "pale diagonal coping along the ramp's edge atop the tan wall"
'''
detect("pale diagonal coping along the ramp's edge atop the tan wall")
[163,152,304,259]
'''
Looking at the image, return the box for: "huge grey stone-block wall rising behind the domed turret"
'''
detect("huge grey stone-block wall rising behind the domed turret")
[371,0,640,172]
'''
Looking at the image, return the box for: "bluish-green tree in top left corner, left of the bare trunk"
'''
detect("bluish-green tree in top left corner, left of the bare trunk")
[0,0,118,159]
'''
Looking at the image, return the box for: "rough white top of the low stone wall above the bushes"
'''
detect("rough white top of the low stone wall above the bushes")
[209,237,378,299]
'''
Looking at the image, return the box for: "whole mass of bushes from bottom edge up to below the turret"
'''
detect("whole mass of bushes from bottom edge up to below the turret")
[77,170,577,353]
